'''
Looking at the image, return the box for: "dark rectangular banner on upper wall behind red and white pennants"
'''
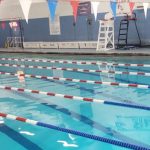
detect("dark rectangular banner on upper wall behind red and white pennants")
[78,2,91,16]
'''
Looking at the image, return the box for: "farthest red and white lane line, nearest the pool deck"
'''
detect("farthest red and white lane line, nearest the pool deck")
[0,58,150,67]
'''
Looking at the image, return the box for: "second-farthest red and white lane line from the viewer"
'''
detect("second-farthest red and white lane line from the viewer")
[0,64,150,77]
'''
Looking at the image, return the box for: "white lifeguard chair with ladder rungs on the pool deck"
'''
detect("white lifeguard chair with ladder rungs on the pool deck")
[96,13,115,51]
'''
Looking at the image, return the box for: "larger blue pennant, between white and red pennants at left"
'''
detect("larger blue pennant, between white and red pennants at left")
[48,0,57,22]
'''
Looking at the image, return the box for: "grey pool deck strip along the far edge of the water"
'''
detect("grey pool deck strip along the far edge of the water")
[0,48,150,56]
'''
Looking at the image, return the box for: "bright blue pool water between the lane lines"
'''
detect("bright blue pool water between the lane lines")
[0,54,150,150]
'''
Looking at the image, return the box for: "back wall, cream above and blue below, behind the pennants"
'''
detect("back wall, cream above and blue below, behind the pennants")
[0,2,150,47]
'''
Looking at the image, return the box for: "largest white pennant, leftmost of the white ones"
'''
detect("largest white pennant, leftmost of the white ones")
[19,0,32,23]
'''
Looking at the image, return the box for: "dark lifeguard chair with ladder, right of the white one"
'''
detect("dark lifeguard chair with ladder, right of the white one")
[117,13,141,49]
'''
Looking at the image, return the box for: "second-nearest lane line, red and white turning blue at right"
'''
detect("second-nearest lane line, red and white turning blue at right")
[0,85,150,111]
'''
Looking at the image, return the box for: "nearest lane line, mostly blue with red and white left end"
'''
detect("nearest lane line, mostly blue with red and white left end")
[0,112,149,150]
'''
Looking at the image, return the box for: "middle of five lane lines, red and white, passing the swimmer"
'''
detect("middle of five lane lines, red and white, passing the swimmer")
[0,72,150,89]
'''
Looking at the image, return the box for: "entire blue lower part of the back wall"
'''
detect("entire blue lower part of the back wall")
[0,10,150,47]
